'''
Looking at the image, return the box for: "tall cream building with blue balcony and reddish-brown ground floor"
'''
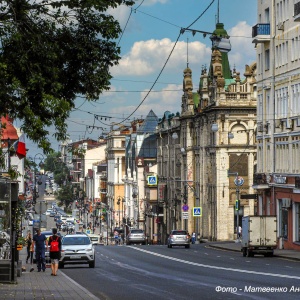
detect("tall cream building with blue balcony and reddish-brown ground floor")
[252,0,300,249]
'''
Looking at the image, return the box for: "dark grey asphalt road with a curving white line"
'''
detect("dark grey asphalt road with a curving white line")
[61,244,300,300]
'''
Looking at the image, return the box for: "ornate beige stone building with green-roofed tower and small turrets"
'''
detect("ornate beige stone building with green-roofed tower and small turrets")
[158,23,256,240]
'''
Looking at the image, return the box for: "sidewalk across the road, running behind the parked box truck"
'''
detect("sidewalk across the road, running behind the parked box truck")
[208,241,300,261]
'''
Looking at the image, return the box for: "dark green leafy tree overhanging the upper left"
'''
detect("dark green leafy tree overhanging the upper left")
[0,0,134,153]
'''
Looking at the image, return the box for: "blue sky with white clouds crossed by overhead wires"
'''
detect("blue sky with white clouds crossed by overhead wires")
[20,0,257,157]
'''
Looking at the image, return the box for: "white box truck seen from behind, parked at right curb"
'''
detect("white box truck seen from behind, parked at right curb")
[241,216,277,257]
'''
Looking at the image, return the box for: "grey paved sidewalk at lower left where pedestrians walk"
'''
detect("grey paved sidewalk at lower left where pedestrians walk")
[0,249,99,300]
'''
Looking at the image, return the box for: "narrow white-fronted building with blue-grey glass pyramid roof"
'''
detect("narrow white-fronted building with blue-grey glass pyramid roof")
[123,110,158,235]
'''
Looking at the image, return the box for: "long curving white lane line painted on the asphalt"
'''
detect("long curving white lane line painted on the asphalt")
[129,246,300,280]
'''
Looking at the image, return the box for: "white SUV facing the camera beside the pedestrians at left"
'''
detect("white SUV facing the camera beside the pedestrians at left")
[59,234,95,269]
